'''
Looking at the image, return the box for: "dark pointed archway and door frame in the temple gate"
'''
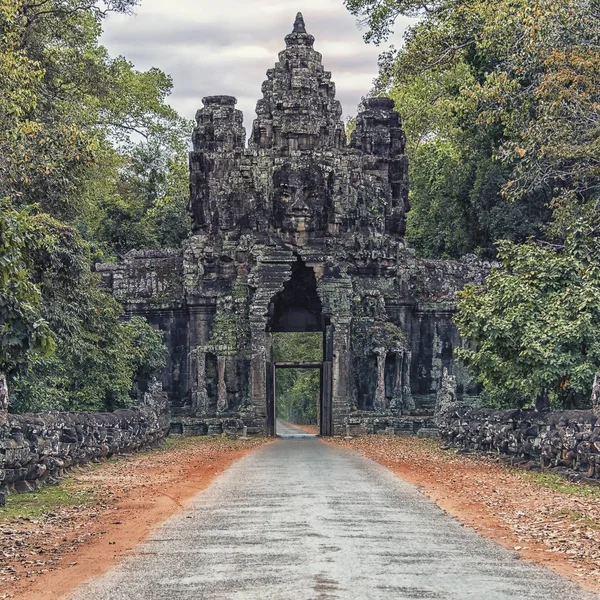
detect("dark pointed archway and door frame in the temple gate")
[266,258,333,436]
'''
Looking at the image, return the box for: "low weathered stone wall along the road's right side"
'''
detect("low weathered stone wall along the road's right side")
[436,403,600,478]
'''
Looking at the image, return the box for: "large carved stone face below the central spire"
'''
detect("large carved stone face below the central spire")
[273,163,331,233]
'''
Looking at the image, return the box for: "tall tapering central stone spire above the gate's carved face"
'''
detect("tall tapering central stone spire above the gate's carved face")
[250,13,346,156]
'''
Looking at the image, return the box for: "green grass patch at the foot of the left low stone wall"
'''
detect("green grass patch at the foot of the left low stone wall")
[0,479,99,521]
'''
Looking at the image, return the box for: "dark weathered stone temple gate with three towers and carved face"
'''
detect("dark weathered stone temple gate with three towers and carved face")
[97,14,484,435]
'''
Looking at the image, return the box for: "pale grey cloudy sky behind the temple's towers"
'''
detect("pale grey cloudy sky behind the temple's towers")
[102,0,414,129]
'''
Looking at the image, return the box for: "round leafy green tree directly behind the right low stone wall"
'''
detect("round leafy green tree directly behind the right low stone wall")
[455,221,600,408]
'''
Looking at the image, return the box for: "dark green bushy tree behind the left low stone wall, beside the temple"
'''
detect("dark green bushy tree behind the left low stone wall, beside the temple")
[11,214,165,412]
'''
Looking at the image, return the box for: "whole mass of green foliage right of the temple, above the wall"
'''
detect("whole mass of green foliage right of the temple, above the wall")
[346,0,600,407]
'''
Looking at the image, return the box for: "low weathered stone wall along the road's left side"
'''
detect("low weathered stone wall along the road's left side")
[0,384,170,506]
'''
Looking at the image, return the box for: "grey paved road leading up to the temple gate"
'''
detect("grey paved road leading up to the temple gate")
[72,439,598,600]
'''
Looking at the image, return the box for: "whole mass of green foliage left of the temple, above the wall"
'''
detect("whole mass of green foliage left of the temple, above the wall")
[0,0,185,410]
